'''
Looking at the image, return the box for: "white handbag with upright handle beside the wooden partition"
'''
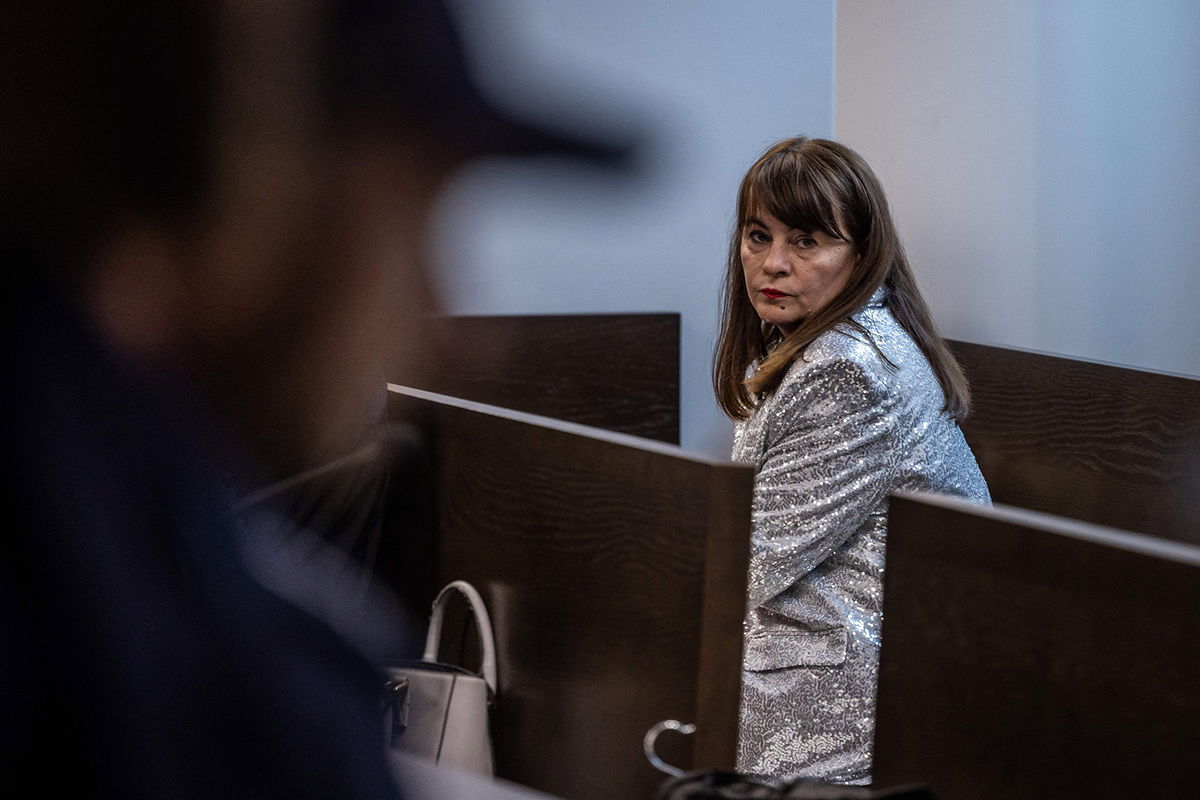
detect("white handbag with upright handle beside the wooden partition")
[384,581,497,776]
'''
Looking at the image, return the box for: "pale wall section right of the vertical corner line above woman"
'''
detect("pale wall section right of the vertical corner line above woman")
[835,0,1200,374]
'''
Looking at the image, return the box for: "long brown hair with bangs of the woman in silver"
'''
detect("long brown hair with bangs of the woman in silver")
[713,137,971,421]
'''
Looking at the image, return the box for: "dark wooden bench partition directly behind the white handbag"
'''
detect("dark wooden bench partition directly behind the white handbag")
[390,387,752,800]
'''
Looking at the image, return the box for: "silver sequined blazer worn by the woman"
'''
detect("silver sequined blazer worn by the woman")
[733,289,989,783]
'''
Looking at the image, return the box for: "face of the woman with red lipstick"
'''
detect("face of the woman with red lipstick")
[740,212,858,336]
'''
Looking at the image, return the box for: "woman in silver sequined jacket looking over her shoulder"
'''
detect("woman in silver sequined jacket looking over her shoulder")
[713,137,989,783]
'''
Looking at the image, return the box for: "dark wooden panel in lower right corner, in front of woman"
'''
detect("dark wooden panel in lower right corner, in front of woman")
[875,497,1200,800]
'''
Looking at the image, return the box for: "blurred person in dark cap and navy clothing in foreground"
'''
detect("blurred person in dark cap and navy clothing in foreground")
[0,0,628,799]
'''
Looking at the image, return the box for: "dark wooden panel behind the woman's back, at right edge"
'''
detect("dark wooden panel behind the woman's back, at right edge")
[950,342,1200,543]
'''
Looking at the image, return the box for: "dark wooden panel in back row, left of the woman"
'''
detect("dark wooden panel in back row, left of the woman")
[414,314,679,444]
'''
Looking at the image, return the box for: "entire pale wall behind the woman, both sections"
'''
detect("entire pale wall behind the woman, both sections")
[434,0,1200,456]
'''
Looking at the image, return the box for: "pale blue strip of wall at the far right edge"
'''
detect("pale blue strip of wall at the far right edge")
[1034,0,1200,374]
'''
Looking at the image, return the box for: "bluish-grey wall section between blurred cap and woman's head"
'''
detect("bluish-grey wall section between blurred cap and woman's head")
[436,0,834,457]
